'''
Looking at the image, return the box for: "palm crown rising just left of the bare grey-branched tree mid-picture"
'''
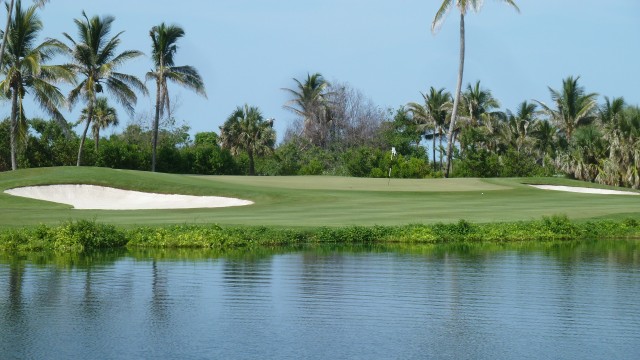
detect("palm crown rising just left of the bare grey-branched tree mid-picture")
[282,73,330,145]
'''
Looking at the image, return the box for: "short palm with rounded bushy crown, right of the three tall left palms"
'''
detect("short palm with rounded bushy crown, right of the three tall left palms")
[220,105,276,175]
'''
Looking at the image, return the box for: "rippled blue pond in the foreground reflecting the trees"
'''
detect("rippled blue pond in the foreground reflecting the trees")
[0,240,640,359]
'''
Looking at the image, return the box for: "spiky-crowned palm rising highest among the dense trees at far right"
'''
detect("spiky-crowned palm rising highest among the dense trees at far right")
[536,76,598,142]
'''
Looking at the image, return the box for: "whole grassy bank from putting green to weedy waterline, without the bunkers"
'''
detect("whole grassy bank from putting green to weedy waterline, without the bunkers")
[0,167,640,252]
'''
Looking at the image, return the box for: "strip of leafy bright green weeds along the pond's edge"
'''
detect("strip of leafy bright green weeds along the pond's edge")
[0,216,640,253]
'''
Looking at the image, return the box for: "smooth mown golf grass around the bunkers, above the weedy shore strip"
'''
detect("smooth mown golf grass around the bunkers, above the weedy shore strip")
[0,167,640,227]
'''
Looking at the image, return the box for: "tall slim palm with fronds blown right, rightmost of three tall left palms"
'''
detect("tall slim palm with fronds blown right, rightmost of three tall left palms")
[147,23,207,171]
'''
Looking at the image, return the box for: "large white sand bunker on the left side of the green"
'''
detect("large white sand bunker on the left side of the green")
[5,185,253,210]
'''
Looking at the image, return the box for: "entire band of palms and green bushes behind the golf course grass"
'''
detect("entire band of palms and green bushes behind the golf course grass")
[0,0,640,188]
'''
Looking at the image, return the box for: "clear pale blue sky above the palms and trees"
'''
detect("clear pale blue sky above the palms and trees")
[5,0,640,138]
